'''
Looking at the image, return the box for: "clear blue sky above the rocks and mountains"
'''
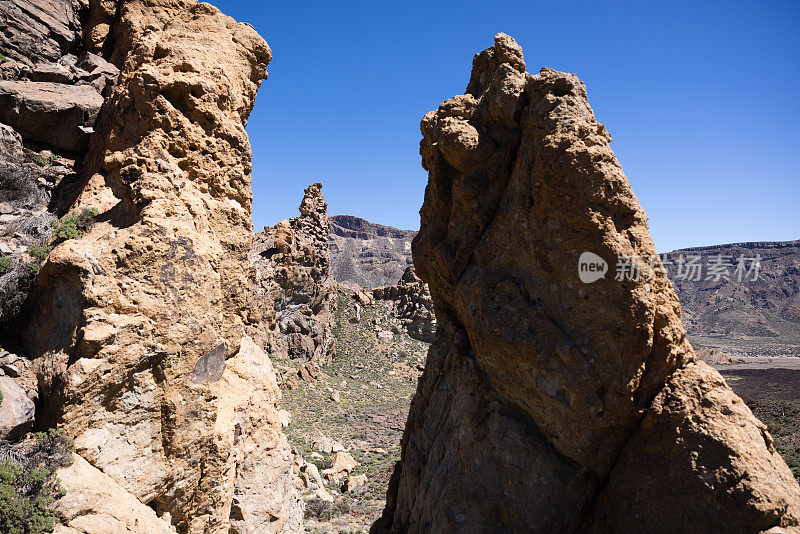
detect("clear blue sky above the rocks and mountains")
[209,0,800,251]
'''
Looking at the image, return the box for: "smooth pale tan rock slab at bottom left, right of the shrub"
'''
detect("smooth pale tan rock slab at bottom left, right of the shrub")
[53,454,175,534]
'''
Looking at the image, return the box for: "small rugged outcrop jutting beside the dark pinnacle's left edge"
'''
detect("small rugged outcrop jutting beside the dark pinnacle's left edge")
[372,265,436,343]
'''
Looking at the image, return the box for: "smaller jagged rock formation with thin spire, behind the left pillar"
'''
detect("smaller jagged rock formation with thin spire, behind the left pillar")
[249,183,336,363]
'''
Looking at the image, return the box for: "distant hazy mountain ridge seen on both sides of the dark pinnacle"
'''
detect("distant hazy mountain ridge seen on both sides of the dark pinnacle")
[329,215,800,356]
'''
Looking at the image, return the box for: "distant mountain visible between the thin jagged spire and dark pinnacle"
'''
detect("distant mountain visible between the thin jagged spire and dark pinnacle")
[330,215,417,289]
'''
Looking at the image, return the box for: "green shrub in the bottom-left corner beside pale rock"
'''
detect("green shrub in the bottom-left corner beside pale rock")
[0,430,74,534]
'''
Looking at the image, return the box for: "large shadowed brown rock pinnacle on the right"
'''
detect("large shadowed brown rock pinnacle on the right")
[375,34,800,533]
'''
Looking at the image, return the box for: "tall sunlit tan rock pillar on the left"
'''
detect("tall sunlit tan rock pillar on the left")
[25,0,302,532]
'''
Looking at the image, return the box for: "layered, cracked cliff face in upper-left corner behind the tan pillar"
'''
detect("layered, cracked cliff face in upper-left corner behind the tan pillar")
[0,0,119,344]
